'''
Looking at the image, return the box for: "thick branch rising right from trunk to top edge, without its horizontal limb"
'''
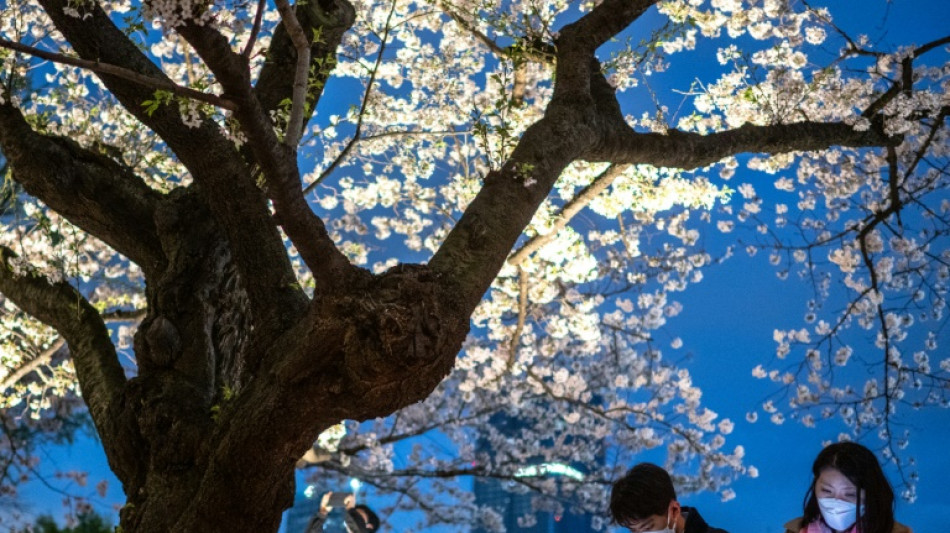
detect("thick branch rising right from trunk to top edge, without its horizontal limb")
[429,7,655,312]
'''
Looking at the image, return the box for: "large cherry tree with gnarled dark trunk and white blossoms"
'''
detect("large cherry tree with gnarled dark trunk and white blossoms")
[0,0,950,532]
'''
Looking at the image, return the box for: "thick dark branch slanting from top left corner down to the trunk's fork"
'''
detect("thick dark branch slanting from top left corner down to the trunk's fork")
[34,0,305,358]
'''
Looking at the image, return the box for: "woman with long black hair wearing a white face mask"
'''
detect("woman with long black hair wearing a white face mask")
[785,442,911,533]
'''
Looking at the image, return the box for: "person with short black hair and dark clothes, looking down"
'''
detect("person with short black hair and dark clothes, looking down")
[610,463,727,533]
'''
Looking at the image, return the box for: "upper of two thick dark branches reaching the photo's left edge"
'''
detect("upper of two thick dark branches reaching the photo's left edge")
[0,91,165,273]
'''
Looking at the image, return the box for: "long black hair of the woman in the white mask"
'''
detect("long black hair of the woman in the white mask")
[802,442,894,533]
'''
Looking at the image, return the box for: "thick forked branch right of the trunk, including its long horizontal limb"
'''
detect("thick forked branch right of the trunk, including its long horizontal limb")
[430,0,899,328]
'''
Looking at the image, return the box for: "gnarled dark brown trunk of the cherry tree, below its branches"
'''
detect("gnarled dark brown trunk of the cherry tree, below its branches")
[103,189,468,533]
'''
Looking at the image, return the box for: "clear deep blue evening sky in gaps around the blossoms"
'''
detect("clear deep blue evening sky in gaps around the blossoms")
[0,0,950,533]
